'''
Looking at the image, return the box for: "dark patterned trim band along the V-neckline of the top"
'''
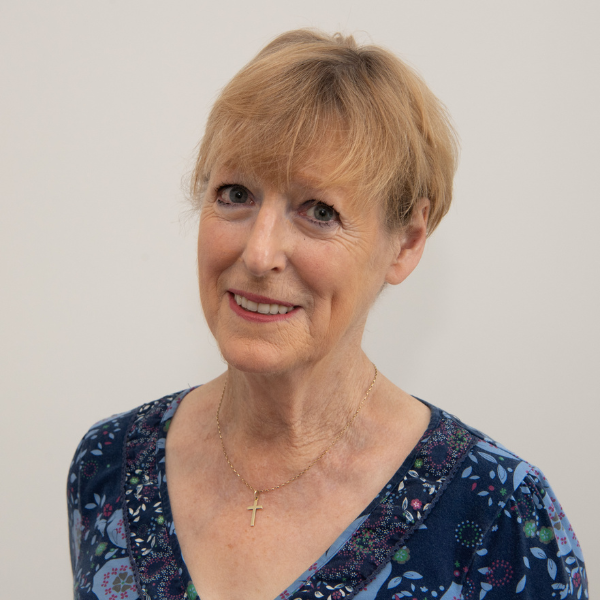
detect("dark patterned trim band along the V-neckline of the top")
[124,388,473,600]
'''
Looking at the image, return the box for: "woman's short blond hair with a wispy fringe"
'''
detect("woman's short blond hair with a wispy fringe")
[191,29,458,233]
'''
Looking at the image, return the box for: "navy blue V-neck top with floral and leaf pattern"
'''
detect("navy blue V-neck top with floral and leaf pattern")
[67,390,588,600]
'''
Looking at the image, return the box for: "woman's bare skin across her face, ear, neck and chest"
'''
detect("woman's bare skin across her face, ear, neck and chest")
[166,161,430,600]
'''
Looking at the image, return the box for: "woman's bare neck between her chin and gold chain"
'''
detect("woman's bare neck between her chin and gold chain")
[220,351,375,468]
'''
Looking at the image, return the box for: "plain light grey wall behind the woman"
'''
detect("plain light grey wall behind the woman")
[0,0,600,600]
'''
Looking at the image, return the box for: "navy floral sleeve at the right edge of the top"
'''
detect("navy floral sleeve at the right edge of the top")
[463,469,589,600]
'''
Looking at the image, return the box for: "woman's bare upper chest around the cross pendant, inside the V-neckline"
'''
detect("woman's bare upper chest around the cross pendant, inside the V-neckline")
[165,382,428,600]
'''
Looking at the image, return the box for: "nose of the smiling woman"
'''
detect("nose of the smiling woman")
[242,201,289,277]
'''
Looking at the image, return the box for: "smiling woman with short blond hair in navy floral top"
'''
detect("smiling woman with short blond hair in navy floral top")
[68,30,587,600]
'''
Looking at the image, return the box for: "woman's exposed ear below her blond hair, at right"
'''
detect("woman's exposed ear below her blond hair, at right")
[385,198,431,285]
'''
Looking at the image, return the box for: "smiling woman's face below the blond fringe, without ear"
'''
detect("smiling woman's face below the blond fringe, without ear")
[198,159,426,373]
